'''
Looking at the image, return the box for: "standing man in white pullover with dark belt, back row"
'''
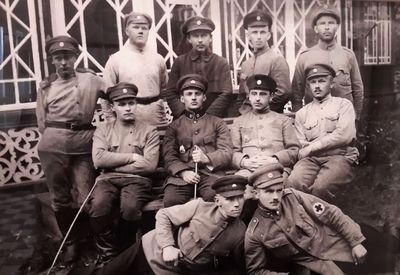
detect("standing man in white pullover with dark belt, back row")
[103,12,168,125]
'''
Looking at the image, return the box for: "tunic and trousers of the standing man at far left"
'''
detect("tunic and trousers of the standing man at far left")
[36,69,104,211]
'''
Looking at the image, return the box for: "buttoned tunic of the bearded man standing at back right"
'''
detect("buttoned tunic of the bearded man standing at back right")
[292,43,364,119]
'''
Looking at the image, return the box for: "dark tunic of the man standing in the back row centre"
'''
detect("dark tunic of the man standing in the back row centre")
[165,50,232,118]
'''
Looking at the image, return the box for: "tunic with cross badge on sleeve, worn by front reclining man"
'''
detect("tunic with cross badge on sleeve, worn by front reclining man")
[245,189,365,275]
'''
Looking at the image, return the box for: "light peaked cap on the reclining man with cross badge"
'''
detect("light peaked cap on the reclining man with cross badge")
[249,163,283,189]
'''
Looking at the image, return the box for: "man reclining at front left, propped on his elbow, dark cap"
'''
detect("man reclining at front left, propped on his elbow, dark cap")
[80,175,247,275]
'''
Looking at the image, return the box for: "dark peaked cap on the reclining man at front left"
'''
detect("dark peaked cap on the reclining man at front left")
[211,175,247,198]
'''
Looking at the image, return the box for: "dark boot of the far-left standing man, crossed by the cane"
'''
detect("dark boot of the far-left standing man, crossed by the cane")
[55,207,78,264]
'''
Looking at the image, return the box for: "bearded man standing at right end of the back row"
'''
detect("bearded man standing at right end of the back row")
[292,8,364,120]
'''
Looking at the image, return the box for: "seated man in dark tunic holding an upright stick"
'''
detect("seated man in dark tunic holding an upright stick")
[162,74,232,207]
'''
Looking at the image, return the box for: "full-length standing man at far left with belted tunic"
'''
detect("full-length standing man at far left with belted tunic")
[36,35,103,268]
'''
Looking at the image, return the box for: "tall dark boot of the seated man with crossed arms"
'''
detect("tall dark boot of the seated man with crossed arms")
[90,216,118,266]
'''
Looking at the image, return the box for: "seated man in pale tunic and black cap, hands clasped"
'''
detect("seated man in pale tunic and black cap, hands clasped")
[231,74,300,180]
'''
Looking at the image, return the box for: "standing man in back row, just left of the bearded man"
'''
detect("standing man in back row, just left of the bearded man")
[237,10,290,114]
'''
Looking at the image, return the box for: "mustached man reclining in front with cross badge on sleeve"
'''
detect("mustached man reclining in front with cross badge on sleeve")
[245,163,367,275]
